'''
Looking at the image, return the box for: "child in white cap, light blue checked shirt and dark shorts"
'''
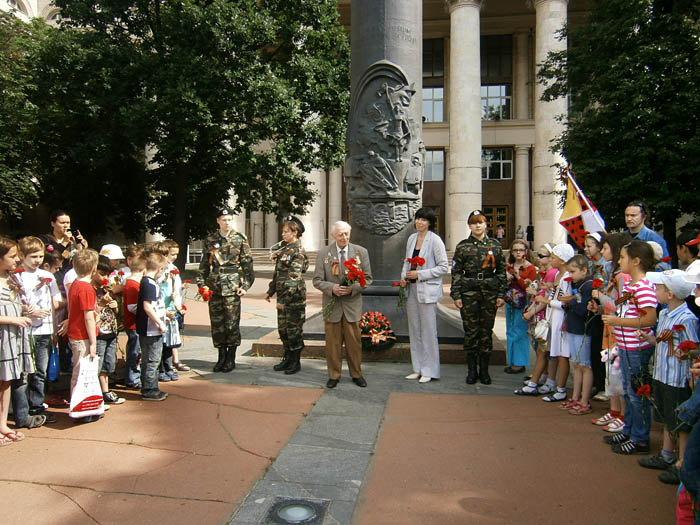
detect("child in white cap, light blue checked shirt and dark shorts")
[639,270,698,485]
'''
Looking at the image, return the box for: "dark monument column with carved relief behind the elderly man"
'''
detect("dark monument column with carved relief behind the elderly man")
[344,0,425,282]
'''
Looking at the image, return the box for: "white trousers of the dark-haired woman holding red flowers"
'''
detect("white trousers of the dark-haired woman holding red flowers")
[406,284,440,379]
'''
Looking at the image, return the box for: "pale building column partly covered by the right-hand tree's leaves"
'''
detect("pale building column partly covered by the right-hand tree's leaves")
[532,0,568,245]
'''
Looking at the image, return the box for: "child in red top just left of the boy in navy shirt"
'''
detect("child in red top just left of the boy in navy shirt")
[122,244,146,390]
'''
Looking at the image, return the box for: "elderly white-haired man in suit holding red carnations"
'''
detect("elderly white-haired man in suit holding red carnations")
[313,221,372,388]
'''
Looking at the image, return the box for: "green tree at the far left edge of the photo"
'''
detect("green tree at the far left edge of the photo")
[0,12,41,220]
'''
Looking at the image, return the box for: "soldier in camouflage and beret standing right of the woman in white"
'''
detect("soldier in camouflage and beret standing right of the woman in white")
[450,210,506,385]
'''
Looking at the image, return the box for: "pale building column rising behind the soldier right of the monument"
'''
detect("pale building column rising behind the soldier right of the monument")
[445,0,481,250]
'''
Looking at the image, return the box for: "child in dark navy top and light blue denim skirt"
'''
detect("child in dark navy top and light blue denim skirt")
[562,255,593,416]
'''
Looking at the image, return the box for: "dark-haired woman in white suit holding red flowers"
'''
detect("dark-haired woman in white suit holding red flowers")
[400,208,449,383]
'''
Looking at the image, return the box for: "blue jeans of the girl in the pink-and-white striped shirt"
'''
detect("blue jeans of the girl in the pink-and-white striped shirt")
[619,347,654,443]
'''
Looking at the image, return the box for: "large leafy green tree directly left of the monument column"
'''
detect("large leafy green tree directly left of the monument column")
[49,0,349,258]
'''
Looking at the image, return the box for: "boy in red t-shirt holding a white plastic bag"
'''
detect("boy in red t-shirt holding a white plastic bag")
[68,248,104,423]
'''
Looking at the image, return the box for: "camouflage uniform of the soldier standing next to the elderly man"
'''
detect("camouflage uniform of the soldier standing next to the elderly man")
[267,240,309,352]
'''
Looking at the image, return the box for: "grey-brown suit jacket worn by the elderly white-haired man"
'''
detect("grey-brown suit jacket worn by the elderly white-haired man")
[313,242,372,323]
